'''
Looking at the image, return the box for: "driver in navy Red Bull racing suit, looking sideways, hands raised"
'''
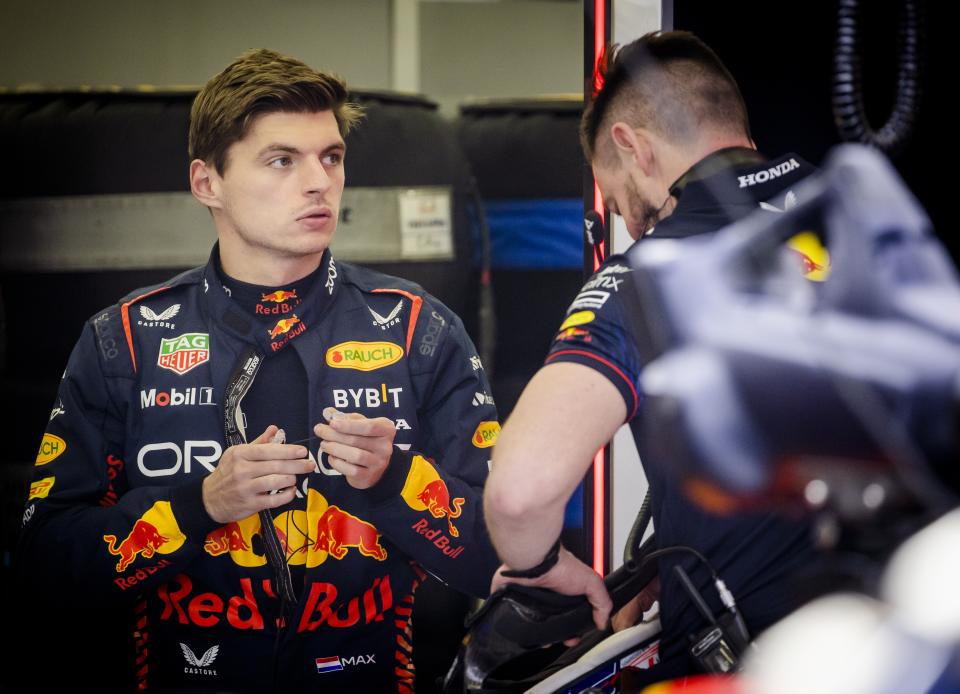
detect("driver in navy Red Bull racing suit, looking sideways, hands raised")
[21,50,499,692]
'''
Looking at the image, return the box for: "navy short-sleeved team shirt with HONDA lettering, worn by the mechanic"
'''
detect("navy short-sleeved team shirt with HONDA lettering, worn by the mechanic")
[547,149,828,677]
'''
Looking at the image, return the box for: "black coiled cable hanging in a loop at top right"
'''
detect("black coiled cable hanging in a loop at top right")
[833,0,923,157]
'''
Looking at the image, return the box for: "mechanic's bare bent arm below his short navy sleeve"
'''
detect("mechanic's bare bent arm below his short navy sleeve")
[484,362,627,628]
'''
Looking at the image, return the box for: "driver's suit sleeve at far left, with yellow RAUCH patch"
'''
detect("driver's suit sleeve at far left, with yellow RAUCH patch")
[18,310,216,604]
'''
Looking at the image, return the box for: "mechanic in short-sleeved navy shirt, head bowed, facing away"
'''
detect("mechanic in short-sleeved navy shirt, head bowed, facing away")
[485,32,813,677]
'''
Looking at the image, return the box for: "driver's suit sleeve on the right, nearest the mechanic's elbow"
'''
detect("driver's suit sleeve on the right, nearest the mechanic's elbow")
[369,305,500,597]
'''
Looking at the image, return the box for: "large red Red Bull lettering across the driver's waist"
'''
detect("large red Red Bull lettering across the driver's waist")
[157,574,393,632]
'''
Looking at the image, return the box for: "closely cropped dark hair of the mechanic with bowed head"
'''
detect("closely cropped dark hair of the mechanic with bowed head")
[580,31,750,160]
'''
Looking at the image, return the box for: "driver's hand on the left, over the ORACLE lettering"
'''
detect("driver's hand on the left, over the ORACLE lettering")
[203,424,315,523]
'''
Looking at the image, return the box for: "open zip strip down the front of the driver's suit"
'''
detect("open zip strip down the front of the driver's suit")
[223,347,297,604]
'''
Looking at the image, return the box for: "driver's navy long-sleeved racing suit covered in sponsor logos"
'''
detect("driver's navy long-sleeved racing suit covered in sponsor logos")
[21,248,499,692]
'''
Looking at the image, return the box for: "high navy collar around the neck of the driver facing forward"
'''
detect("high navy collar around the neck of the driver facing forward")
[203,243,340,354]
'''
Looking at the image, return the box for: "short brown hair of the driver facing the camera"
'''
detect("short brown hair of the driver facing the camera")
[188,48,363,174]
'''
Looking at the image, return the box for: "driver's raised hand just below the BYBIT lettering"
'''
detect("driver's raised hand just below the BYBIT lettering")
[313,407,397,489]
